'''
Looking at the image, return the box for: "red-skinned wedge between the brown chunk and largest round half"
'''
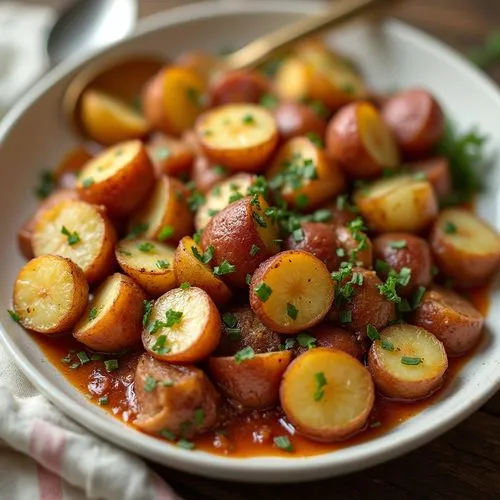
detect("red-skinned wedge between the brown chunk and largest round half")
[208,351,292,410]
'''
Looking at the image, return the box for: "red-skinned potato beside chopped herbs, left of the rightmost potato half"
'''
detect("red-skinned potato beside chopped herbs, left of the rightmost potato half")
[373,233,432,297]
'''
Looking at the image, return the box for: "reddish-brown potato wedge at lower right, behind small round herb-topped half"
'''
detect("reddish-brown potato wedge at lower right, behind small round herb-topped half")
[411,285,484,356]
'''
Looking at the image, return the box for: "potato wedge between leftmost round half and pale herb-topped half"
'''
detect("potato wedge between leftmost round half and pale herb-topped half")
[73,273,146,352]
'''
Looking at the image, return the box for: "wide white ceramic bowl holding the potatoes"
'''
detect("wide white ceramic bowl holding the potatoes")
[0,0,500,482]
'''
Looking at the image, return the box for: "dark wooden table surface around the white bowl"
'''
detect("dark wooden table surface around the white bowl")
[27,0,500,500]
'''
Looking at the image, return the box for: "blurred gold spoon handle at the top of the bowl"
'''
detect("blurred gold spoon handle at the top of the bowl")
[224,0,395,70]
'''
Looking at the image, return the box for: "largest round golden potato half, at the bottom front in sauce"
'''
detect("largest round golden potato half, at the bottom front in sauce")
[280,348,375,442]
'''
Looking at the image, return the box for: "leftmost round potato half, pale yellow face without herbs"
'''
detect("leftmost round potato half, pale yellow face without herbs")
[13,255,89,335]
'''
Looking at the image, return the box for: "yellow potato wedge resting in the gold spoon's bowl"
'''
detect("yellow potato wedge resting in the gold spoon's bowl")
[80,89,149,146]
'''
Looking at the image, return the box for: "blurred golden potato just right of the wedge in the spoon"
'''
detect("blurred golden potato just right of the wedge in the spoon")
[143,66,206,136]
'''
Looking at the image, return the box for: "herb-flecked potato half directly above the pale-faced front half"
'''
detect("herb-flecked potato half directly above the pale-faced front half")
[115,239,175,297]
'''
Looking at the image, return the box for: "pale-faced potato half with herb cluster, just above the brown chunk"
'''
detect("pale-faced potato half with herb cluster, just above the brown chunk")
[142,287,221,363]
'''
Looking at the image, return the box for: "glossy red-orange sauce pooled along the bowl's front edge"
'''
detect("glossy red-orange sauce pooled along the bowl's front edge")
[33,288,489,457]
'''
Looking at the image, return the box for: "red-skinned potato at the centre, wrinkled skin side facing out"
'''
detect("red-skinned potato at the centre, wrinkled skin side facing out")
[201,196,279,287]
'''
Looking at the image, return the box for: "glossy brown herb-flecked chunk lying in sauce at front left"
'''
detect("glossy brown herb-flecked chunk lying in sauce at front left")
[134,354,220,439]
